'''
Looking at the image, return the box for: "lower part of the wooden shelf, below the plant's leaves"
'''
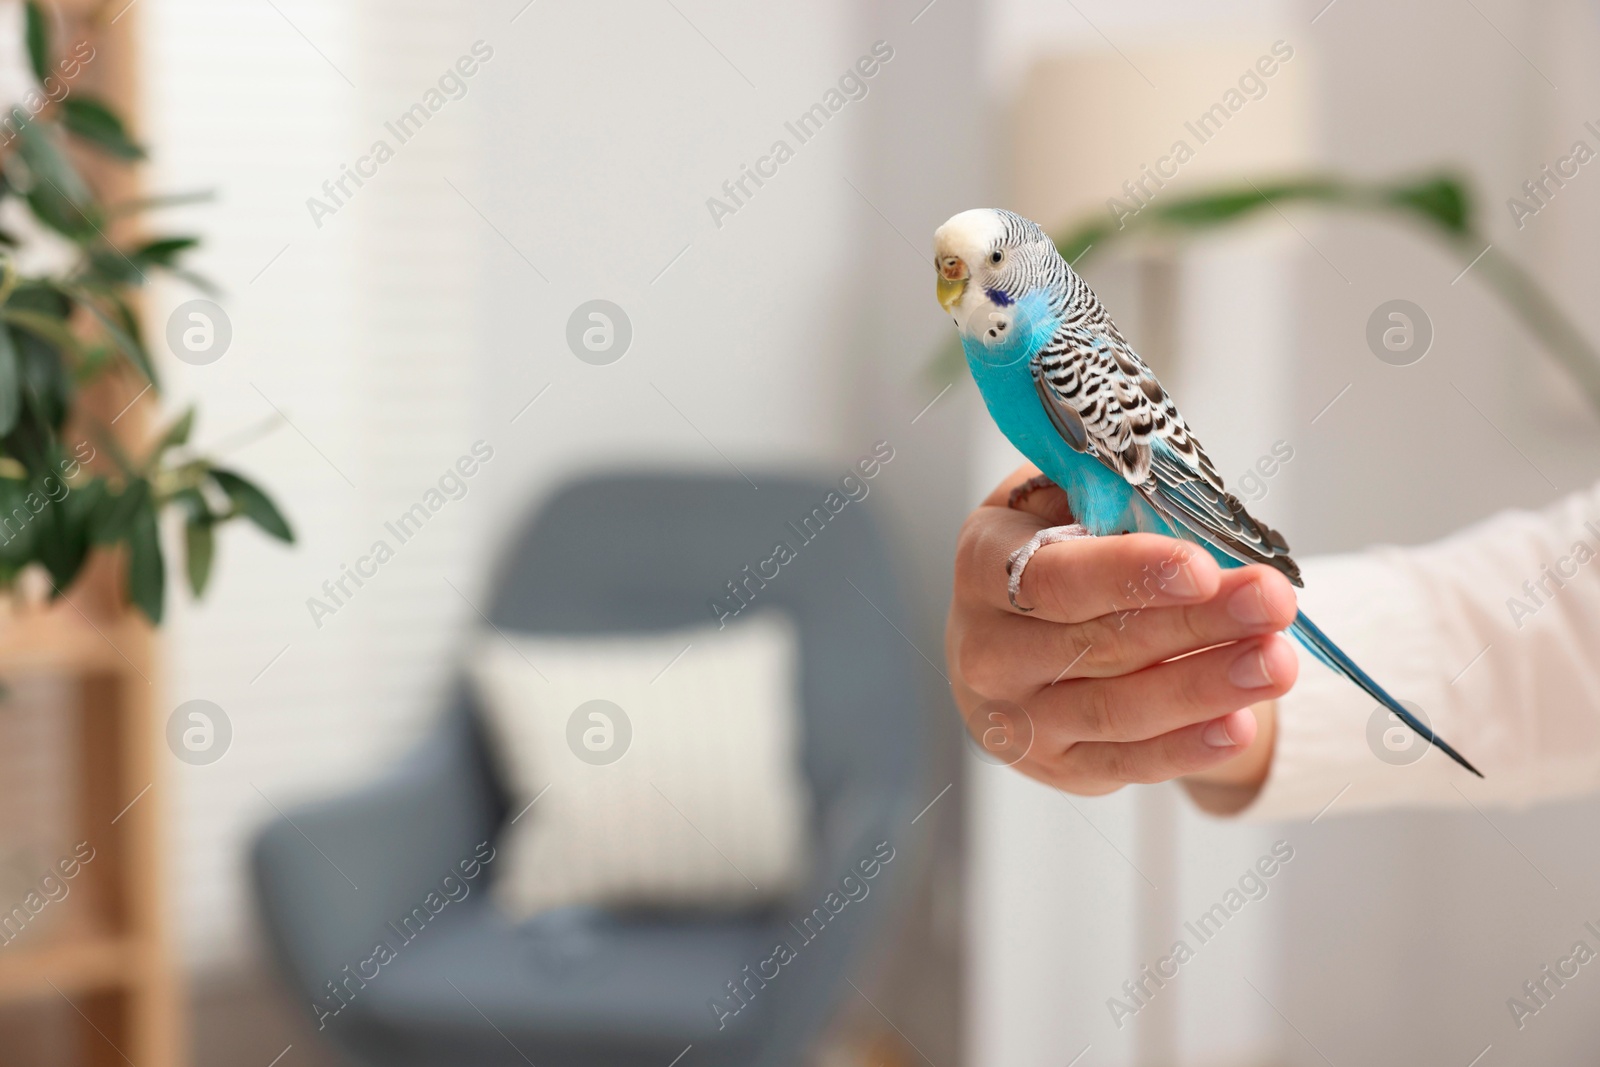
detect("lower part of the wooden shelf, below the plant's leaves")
[0,591,184,1067]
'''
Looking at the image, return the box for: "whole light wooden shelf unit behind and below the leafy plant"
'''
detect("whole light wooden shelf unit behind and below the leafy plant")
[0,0,187,1067]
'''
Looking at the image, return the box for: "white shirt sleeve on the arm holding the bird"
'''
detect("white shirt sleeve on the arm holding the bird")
[1243,486,1600,819]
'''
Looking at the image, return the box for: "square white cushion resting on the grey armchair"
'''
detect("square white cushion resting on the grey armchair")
[469,613,810,918]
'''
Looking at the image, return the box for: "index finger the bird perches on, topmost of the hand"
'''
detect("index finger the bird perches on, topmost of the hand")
[957,507,1222,622]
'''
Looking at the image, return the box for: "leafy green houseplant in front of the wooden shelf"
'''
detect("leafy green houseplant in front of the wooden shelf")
[0,0,294,622]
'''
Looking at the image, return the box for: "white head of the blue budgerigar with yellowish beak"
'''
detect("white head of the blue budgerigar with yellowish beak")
[933,208,1059,356]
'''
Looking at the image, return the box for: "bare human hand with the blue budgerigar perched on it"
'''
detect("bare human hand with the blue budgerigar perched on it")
[946,466,1298,811]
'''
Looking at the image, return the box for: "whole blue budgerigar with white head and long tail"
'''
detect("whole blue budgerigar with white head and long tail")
[933,208,1483,777]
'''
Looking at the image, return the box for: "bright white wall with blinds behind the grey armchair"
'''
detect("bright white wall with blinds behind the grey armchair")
[139,0,898,968]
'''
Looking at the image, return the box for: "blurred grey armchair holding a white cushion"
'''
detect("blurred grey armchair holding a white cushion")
[253,475,930,1067]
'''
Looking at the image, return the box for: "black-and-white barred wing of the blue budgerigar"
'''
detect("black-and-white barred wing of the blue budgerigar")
[1029,271,1301,585]
